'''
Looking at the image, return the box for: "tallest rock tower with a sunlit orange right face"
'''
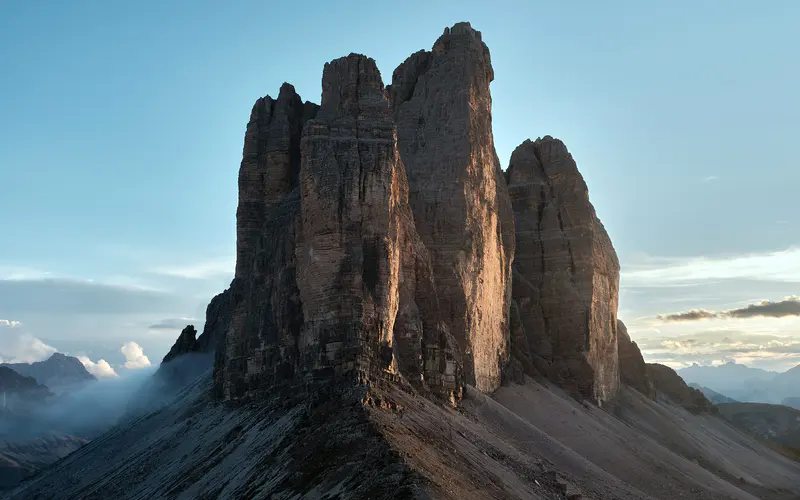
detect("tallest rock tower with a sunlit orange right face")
[389,23,514,391]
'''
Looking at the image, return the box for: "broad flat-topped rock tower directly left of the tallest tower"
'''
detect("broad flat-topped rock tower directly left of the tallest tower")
[297,54,456,396]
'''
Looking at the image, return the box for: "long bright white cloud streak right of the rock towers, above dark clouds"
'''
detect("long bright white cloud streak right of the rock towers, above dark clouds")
[620,247,800,287]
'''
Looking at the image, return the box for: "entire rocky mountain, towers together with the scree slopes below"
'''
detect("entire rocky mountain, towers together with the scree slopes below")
[9,23,800,500]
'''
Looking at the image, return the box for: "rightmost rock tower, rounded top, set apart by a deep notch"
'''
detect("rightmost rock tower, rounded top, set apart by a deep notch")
[506,136,619,402]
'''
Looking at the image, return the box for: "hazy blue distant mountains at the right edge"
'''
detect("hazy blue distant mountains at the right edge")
[678,362,800,404]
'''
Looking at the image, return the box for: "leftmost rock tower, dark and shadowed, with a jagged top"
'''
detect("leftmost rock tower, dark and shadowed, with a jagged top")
[219,84,318,399]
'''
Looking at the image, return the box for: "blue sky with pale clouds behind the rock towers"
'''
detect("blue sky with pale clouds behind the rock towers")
[0,0,800,371]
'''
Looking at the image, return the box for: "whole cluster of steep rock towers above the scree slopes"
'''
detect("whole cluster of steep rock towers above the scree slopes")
[165,23,644,404]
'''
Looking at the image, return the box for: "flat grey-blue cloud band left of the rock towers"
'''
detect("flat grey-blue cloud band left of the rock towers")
[0,278,177,315]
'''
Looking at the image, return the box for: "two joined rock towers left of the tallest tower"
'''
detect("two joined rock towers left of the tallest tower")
[215,54,460,400]
